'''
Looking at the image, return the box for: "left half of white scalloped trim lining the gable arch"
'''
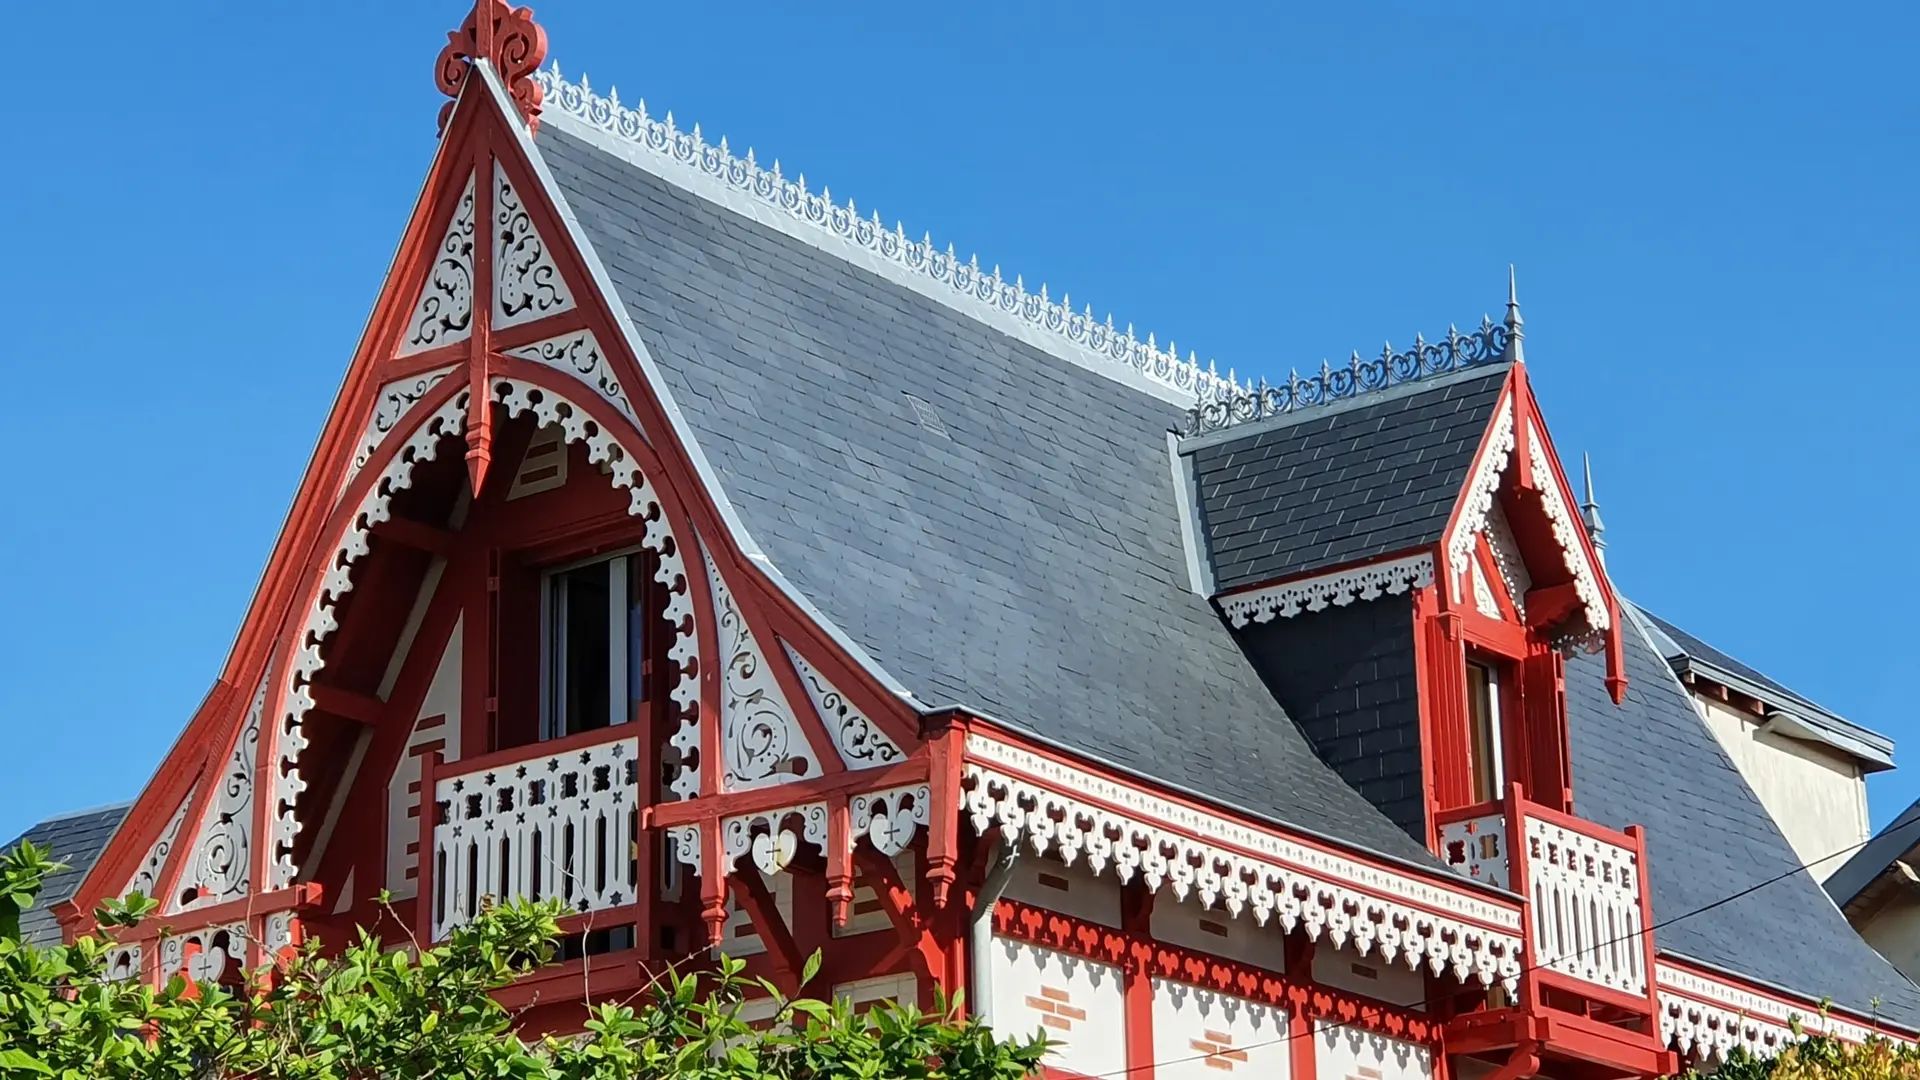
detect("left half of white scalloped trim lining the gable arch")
[267,390,467,890]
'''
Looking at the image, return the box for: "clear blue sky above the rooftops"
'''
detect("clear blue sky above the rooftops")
[0,0,1920,834]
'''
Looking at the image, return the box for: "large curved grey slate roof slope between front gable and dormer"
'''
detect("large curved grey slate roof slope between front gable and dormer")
[538,123,1436,865]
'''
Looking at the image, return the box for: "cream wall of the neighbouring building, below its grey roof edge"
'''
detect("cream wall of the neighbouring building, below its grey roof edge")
[1693,694,1872,878]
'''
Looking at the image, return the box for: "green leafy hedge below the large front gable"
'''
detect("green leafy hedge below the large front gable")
[0,844,1046,1080]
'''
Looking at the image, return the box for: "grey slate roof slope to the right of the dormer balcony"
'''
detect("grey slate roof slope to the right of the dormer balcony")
[1567,617,1920,1030]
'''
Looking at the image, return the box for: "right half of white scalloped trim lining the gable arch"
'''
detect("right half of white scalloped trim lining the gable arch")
[492,379,701,799]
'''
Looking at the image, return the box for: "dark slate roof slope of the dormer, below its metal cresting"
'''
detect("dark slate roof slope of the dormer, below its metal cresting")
[1192,363,1511,590]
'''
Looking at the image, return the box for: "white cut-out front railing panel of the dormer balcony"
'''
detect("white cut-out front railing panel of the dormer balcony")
[1524,815,1647,997]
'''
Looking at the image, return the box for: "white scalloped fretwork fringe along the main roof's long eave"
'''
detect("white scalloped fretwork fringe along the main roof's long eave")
[962,736,1523,992]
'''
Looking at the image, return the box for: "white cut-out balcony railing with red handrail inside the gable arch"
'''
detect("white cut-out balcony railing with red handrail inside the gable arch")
[419,726,639,942]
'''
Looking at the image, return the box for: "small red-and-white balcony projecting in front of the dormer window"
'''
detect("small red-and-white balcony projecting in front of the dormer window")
[1436,784,1653,1013]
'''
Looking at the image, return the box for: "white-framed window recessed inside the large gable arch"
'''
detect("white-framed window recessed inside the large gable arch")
[541,552,653,738]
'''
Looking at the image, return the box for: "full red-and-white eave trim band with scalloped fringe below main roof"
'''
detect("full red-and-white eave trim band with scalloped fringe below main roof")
[962,732,1524,992]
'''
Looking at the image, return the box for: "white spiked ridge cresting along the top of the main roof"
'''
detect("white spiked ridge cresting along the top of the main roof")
[534,63,1242,405]
